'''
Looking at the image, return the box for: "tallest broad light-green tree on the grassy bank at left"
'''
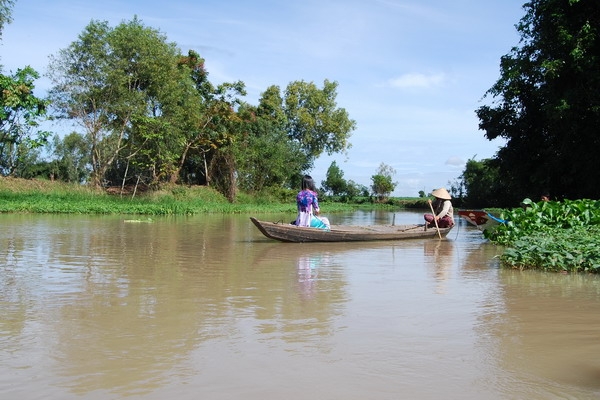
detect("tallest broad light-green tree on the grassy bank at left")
[49,18,199,186]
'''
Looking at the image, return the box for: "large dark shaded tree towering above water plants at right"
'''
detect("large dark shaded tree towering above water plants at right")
[476,0,600,205]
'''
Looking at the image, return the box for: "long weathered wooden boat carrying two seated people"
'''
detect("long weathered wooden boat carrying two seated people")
[250,217,452,242]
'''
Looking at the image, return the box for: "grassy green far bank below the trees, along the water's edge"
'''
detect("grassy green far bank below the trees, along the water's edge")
[0,178,426,215]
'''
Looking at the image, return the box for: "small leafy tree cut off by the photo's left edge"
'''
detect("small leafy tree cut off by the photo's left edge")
[0,67,50,176]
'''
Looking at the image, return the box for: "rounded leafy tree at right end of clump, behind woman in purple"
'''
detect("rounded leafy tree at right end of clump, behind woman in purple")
[234,81,355,194]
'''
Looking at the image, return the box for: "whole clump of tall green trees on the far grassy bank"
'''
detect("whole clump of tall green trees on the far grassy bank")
[49,17,355,202]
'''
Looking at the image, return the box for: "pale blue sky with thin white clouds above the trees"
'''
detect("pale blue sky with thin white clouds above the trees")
[0,0,525,197]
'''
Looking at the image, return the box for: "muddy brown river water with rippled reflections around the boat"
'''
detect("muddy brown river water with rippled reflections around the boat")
[0,212,600,400]
